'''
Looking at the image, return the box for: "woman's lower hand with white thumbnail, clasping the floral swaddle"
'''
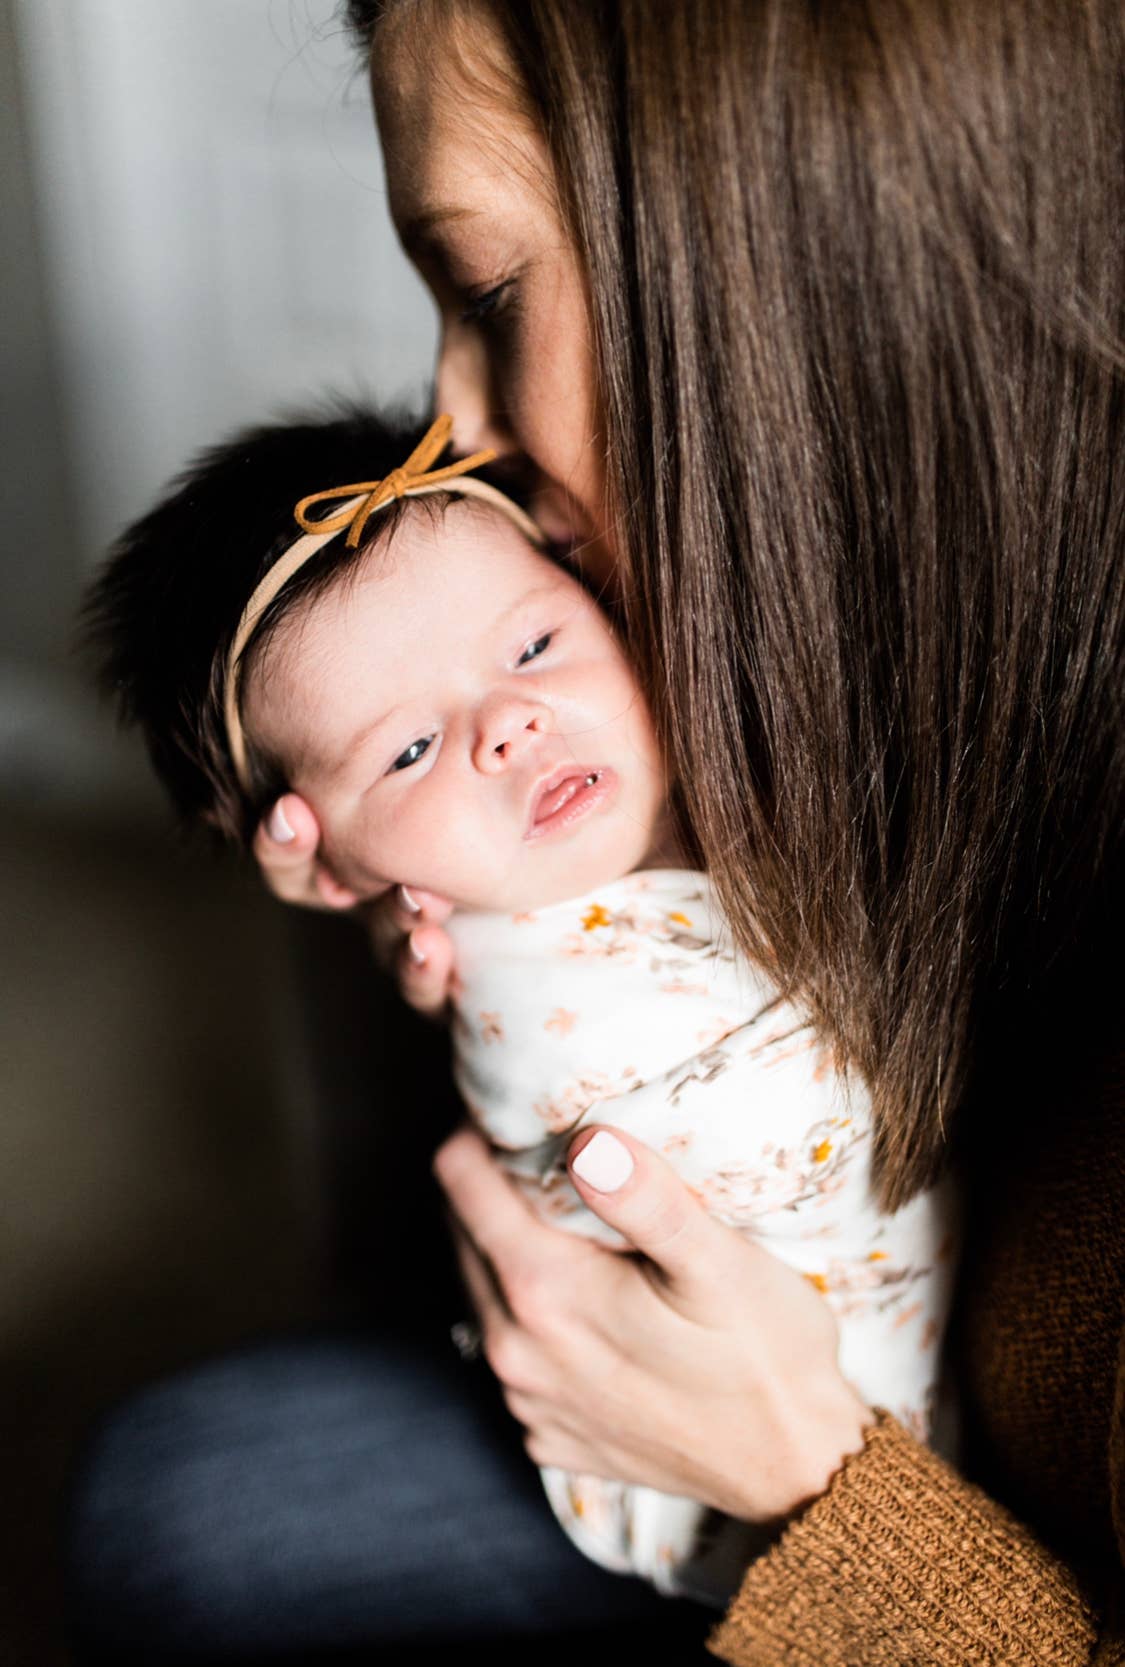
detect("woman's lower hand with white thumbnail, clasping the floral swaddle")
[433,1129,873,1524]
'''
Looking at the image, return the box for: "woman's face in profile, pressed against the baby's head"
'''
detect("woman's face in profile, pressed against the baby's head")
[372,10,612,582]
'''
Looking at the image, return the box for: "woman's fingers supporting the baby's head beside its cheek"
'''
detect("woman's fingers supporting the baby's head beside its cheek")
[253,793,453,1014]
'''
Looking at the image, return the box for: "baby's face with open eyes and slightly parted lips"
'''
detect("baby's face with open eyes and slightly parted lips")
[245,500,665,910]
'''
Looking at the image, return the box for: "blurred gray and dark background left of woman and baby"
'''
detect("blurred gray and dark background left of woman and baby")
[0,0,433,1667]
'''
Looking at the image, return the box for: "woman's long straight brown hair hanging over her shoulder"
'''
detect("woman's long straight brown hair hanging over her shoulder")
[352,0,1125,1207]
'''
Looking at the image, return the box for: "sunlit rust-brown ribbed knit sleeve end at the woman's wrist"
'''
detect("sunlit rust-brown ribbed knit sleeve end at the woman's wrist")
[708,1414,1097,1667]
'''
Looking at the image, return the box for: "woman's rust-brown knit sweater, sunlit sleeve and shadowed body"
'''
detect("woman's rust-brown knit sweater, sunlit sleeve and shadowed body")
[710,1064,1125,1667]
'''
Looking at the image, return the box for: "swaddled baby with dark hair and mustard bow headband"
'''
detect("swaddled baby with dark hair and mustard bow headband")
[88,400,952,1602]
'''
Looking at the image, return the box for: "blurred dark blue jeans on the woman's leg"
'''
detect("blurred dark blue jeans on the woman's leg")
[67,1335,715,1667]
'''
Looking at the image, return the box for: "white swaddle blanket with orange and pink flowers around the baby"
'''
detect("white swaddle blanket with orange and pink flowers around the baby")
[450,870,955,1604]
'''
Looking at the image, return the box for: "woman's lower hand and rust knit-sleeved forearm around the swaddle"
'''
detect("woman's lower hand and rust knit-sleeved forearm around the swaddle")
[435,1132,1125,1667]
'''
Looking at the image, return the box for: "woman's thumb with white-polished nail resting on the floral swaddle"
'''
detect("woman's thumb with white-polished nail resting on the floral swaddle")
[567,1127,723,1285]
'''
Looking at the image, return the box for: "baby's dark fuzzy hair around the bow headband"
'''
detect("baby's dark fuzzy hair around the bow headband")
[82,405,463,849]
